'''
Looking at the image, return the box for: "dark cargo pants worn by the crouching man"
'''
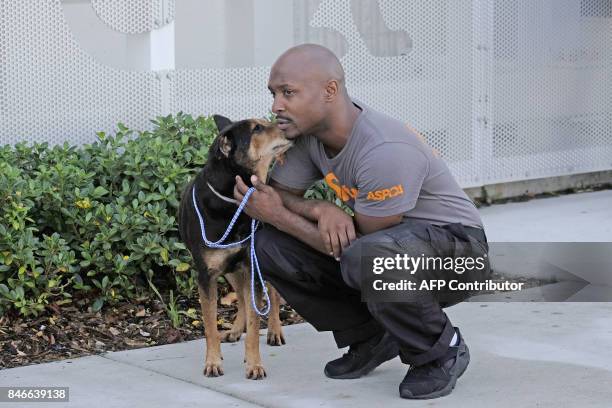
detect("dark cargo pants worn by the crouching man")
[255,218,490,365]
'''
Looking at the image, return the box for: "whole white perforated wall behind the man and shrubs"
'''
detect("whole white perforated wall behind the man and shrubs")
[0,0,612,187]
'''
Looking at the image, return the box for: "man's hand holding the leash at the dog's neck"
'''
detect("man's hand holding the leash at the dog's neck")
[234,176,285,226]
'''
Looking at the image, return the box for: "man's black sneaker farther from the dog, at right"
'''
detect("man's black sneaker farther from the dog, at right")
[399,327,470,399]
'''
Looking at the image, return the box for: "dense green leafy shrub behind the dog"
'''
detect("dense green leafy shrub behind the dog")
[0,113,346,316]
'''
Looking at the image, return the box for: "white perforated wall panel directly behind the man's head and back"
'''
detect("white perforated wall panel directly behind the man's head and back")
[173,0,479,185]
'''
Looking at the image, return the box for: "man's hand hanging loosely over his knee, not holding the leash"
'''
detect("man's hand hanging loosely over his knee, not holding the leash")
[316,202,357,260]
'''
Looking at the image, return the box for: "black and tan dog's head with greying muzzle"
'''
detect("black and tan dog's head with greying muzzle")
[209,115,293,181]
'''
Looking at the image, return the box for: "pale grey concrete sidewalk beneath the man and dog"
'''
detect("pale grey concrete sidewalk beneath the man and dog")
[0,191,612,408]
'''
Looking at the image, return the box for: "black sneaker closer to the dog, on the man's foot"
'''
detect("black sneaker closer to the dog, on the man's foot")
[324,333,399,380]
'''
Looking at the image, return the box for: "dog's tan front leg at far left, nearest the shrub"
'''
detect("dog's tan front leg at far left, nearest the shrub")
[198,278,223,377]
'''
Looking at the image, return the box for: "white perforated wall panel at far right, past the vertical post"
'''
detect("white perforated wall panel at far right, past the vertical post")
[485,0,612,182]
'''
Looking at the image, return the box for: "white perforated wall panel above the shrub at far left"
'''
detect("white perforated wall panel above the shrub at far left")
[0,0,161,144]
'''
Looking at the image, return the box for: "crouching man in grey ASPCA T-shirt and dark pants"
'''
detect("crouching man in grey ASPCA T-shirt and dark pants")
[234,44,488,399]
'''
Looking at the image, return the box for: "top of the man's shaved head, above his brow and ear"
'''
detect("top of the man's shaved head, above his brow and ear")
[271,44,346,93]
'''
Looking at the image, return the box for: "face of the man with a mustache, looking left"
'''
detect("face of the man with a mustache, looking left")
[268,63,325,139]
